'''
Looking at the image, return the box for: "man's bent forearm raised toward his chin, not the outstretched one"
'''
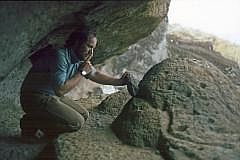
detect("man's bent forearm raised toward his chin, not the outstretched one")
[55,73,81,96]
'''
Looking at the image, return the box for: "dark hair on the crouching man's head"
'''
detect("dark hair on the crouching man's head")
[65,26,96,47]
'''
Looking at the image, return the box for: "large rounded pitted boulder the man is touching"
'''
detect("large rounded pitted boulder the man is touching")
[112,58,240,159]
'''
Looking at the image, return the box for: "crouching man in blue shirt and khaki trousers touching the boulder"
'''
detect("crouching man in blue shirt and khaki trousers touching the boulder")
[20,27,129,141]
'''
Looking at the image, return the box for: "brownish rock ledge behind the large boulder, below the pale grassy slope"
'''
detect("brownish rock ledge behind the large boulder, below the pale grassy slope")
[167,34,240,86]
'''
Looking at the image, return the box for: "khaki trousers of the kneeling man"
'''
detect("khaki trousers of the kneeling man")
[20,93,89,134]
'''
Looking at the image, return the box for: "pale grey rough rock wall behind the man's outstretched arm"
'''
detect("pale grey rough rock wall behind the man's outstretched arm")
[100,19,168,80]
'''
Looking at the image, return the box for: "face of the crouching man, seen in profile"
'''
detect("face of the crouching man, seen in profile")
[75,36,97,61]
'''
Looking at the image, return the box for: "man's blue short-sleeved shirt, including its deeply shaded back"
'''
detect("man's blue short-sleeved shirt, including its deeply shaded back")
[21,48,83,95]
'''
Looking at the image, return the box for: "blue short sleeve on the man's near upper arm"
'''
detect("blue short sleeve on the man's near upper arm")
[51,50,68,88]
